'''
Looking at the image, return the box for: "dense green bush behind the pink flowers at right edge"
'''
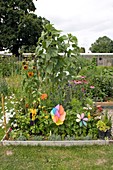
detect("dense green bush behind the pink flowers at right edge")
[79,66,113,101]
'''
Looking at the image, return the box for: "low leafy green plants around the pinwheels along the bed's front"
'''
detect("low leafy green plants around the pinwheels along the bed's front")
[6,93,97,140]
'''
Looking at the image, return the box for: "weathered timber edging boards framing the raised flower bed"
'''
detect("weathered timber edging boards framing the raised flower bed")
[0,102,113,146]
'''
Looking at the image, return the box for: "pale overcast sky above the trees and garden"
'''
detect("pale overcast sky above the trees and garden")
[34,0,113,52]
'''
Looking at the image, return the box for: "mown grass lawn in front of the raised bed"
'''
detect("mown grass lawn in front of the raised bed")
[0,145,113,170]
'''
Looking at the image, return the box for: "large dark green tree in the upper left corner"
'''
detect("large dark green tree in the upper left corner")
[0,0,47,56]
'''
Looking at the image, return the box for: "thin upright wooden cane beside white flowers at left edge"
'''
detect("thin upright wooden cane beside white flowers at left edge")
[1,94,8,139]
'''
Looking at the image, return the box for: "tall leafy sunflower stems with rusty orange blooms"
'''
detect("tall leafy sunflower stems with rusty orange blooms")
[22,62,41,108]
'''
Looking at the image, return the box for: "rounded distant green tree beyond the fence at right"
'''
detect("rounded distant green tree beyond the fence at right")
[89,36,113,53]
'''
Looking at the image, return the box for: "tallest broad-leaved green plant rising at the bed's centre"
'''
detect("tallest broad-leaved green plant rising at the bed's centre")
[36,24,79,103]
